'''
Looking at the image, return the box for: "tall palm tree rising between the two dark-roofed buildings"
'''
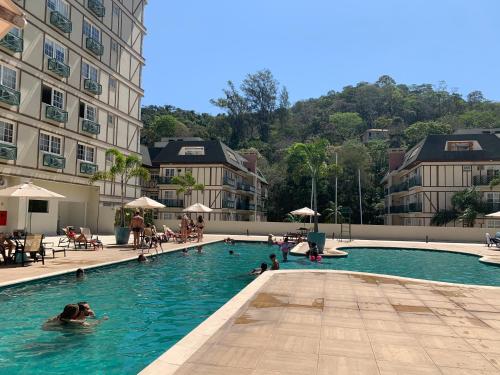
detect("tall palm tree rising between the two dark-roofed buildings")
[287,139,336,232]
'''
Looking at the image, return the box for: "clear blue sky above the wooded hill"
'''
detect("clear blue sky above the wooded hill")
[143,0,500,113]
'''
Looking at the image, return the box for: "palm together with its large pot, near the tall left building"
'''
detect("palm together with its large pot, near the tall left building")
[89,148,150,245]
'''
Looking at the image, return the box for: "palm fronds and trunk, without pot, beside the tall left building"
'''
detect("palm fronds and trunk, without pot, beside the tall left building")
[89,148,150,228]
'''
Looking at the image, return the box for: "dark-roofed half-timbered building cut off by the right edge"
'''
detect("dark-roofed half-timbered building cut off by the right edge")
[383,133,500,228]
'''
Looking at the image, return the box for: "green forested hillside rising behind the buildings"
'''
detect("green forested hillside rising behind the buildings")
[142,70,500,224]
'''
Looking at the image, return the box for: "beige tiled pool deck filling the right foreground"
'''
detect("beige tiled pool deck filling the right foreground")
[164,271,500,375]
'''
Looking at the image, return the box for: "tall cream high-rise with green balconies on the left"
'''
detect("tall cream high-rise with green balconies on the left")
[0,0,146,233]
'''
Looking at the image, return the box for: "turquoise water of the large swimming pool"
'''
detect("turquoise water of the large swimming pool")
[0,243,500,374]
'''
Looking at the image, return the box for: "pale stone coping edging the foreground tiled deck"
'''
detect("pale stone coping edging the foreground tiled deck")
[139,270,500,375]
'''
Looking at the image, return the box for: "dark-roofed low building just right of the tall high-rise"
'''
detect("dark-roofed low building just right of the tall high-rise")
[142,139,268,221]
